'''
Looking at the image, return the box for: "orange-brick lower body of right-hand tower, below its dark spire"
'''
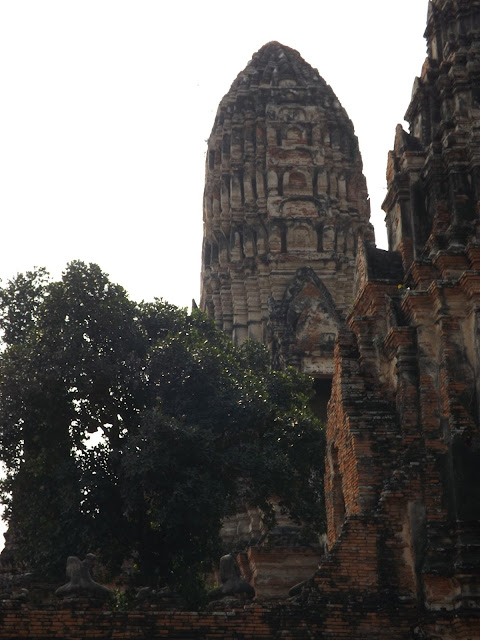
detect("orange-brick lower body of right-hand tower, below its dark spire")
[319,256,480,609]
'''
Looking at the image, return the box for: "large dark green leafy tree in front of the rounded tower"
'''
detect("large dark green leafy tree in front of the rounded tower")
[0,262,324,600]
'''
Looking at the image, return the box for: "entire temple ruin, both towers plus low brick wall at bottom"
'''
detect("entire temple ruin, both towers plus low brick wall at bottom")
[0,0,480,640]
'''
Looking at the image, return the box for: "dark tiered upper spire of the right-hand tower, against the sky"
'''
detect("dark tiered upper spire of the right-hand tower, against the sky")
[383,0,480,270]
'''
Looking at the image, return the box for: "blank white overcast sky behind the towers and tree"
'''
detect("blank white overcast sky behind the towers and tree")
[0,0,427,306]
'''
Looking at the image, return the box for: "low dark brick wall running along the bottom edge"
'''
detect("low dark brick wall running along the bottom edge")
[0,593,480,640]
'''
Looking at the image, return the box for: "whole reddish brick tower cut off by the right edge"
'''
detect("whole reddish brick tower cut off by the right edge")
[303,0,480,640]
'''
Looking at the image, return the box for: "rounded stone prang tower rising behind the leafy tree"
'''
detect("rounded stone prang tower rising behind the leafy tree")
[200,42,373,378]
